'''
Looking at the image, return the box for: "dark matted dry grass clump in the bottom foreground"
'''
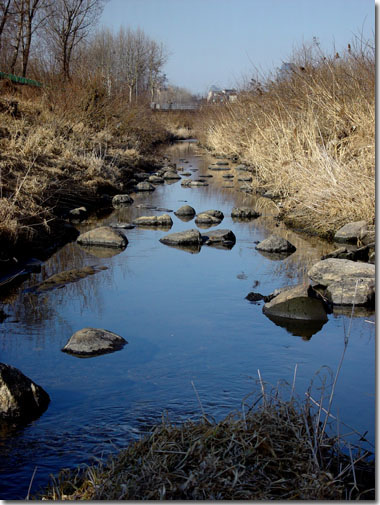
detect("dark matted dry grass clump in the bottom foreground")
[35,382,374,501]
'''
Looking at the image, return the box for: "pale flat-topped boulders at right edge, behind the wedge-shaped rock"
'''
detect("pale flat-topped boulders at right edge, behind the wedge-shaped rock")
[308,258,375,307]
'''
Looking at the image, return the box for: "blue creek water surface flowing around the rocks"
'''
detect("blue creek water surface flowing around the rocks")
[0,141,375,499]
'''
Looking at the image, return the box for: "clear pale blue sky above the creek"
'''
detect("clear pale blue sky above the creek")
[100,0,375,94]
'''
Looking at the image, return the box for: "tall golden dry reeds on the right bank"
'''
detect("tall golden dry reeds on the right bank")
[197,39,375,236]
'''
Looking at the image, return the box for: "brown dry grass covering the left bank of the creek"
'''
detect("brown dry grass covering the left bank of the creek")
[0,77,169,254]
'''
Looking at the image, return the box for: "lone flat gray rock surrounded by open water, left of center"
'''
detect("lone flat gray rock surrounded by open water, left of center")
[62,328,128,357]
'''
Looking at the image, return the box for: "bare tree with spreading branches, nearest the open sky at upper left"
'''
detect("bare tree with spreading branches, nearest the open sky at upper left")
[46,0,104,80]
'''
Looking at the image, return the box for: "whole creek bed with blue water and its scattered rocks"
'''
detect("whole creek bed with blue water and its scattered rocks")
[0,142,375,499]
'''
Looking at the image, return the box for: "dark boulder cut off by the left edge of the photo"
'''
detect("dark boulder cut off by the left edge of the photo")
[0,363,50,421]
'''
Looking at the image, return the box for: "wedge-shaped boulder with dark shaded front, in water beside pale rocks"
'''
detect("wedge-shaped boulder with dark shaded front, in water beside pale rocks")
[263,284,328,322]
